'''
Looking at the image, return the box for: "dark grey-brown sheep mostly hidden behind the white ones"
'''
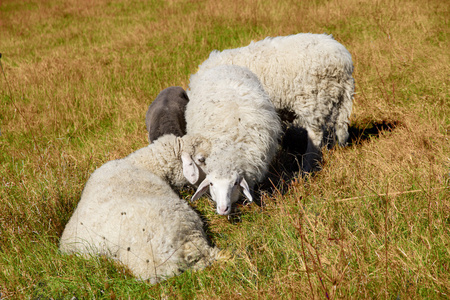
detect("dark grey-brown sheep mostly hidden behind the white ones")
[145,86,189,143]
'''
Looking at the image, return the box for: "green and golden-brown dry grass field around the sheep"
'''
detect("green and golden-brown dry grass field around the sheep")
[0,0,450,299]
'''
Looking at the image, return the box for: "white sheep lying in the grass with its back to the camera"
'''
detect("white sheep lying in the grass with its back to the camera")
[60,134,219,283]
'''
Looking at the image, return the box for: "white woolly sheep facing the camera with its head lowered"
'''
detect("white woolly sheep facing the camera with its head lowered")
[186,65,281,215]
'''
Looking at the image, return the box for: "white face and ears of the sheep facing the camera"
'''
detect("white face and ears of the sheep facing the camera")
[191,172,253,215]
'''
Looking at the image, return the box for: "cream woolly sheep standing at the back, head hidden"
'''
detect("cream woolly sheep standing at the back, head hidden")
[198,33,354,172]
